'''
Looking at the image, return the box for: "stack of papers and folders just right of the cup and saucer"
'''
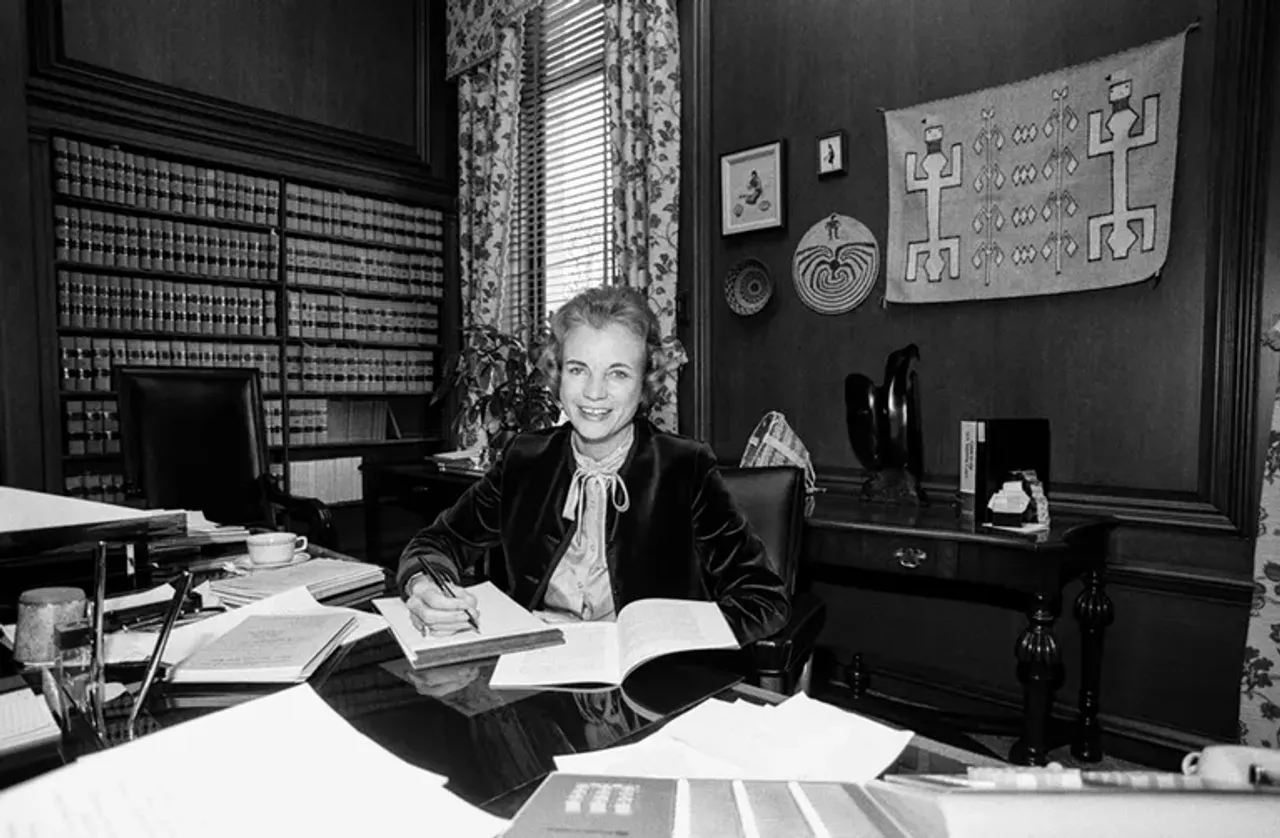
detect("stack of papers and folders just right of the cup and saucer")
[210,559,387,608]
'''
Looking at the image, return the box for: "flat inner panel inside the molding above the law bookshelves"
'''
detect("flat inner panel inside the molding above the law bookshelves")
[61,0,417,146]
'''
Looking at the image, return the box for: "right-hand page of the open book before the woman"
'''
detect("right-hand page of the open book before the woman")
[618,599,737,676]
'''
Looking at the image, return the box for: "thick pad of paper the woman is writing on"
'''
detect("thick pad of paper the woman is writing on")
[374,582,564,669]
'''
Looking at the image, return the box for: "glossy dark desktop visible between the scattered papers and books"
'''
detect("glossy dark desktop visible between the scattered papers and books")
[47,633,997,816]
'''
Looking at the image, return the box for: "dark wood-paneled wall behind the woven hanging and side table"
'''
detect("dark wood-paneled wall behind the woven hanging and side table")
[685,0,1280,742]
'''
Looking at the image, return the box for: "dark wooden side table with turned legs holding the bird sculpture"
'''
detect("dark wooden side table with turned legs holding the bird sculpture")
[809,495,1115,765]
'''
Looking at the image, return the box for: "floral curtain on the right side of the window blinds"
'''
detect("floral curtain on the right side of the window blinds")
[604,0,684,431]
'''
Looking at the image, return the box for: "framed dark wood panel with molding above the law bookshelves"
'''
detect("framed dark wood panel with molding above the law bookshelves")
[27,0,457,189]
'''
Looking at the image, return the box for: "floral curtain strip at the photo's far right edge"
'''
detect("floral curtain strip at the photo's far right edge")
[1240,322,1280,747]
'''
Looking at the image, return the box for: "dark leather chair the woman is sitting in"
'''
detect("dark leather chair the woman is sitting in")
[721,466,827,695]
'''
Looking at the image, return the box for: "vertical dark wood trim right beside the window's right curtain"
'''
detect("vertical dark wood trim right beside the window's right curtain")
[680,0,719,440]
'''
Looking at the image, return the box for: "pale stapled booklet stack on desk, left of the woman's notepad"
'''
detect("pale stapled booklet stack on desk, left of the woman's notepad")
[169,613,356,683]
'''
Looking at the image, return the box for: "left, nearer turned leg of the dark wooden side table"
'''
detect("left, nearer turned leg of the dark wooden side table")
[1009,595,1062,765]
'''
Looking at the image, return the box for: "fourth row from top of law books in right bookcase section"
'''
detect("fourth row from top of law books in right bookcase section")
[285,344,435,394]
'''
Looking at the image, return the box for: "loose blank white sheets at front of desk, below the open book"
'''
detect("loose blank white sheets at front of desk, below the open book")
[556,693,913,783]
